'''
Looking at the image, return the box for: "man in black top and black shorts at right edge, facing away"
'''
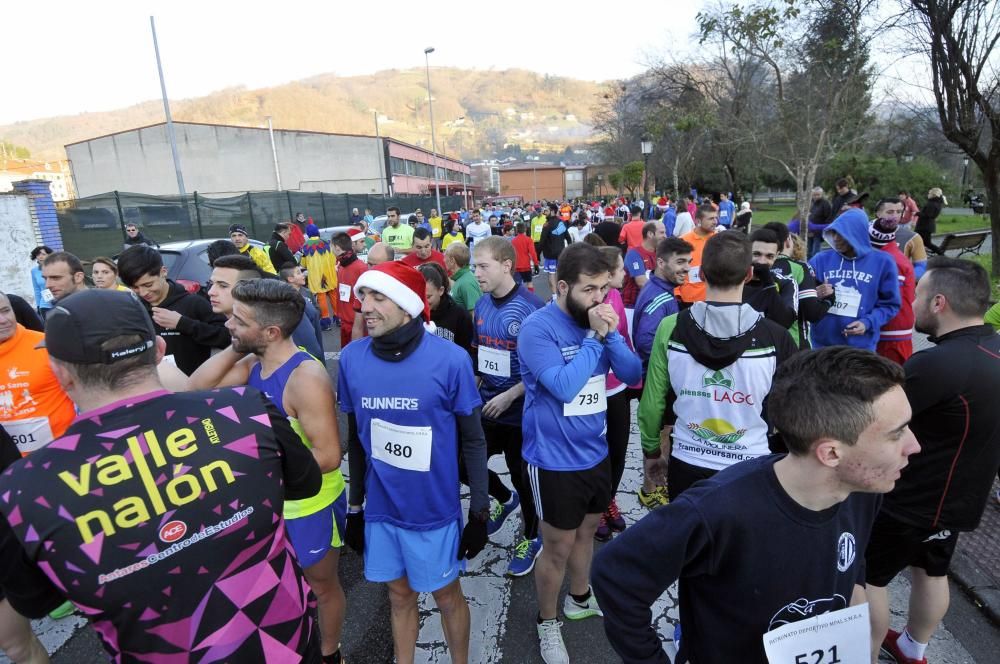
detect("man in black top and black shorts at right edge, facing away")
[865,257,1000,664]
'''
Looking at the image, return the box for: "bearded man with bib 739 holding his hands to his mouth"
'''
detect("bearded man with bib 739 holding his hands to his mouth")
[517,243,642,664]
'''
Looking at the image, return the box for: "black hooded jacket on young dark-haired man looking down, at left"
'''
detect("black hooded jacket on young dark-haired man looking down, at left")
[144,279,233,376]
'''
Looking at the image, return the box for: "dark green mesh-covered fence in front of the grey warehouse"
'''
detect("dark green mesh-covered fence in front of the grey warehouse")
[56,191,465,260]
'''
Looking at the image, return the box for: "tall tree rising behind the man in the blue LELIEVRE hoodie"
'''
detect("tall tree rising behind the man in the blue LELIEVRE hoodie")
[698,0,874,230]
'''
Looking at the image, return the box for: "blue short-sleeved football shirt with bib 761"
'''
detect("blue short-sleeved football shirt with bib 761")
[472,285,545,426]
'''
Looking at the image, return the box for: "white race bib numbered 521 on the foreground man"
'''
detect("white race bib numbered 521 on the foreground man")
[764,603,871,664]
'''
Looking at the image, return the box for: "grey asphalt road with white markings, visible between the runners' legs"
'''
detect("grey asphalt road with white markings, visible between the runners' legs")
[15,270,1000,664]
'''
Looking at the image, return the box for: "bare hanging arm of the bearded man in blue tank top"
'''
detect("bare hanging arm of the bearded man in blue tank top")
[283,362,341,473]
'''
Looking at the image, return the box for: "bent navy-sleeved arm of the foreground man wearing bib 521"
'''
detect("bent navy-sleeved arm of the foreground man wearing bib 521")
[591,497,712,664]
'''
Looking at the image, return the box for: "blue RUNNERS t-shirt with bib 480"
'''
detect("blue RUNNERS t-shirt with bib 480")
[337,333,482,530]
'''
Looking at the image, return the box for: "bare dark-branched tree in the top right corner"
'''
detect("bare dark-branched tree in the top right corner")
[910,0,1000,277]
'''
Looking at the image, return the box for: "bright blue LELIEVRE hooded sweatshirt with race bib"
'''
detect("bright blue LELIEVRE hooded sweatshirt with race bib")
[809,209,900,352]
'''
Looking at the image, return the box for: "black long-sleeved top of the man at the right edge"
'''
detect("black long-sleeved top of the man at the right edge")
[883,325,1000,531]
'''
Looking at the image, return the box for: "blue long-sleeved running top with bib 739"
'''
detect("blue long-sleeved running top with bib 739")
[517,303,642,471]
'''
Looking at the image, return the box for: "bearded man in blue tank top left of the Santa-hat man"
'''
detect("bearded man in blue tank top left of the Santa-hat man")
[189,279,347,664]
